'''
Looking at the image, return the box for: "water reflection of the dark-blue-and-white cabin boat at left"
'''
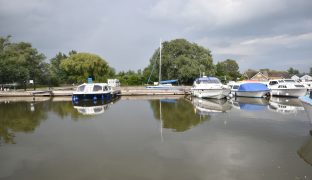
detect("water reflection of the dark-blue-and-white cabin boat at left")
[74,100,116,115]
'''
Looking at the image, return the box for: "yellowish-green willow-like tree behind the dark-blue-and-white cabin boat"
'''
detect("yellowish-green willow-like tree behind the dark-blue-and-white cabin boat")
[60,53,115,83]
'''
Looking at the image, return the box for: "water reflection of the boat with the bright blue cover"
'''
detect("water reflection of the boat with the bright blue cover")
[230,97,269,111]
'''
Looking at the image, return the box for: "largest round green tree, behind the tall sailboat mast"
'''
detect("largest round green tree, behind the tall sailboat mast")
[143,39,215,84]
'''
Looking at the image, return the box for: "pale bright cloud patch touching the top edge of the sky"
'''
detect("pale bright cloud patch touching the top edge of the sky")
[150,0,286,26]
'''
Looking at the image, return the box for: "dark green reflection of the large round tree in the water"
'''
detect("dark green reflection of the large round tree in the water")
[150,98,209,132]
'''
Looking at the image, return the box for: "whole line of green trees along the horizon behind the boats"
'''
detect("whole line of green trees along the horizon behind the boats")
[0,36,312,88]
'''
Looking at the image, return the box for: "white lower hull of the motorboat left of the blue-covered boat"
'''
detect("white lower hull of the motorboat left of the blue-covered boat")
[191,89,230,99]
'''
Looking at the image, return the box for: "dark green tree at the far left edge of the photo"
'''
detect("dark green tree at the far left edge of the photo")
[0,36,49,88]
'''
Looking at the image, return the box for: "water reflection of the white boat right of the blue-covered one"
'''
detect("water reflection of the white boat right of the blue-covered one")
[269,97,304,114]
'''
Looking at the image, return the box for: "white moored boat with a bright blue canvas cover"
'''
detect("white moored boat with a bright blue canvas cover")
[233,83,270,97]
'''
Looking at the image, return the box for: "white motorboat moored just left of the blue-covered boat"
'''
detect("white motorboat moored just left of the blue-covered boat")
[191,76,230,99]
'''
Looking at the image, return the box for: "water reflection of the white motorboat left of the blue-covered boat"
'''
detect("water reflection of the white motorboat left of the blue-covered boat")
[192,98,232,115]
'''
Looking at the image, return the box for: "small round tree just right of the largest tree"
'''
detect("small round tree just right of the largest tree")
[216,59,241,81]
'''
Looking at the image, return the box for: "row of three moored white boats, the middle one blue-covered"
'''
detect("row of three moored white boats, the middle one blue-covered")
[191,76,308,99]
